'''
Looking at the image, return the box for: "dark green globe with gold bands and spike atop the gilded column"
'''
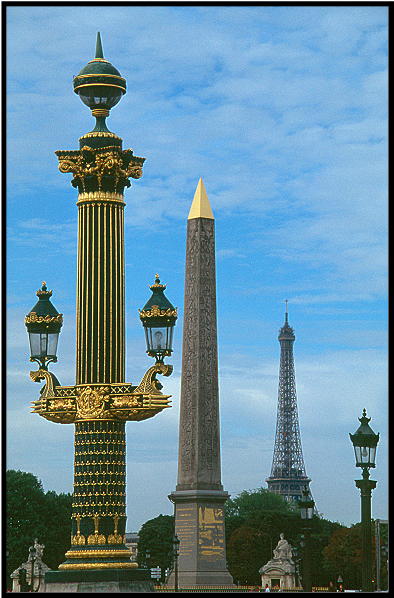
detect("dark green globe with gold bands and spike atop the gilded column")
[73,33,126,118]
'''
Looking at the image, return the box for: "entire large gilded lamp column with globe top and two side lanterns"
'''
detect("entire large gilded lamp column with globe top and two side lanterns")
[25,34,177,591]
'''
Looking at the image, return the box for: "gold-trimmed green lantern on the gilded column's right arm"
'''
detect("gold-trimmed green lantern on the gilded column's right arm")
[138,274,178,362]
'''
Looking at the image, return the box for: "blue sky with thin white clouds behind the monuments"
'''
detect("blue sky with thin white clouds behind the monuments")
[7,5,388,531]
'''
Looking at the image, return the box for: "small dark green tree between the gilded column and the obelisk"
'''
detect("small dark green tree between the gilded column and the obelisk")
[137,515,175,582]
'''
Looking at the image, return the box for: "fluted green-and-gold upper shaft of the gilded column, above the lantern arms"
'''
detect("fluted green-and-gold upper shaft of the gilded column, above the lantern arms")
[76,192,125,384]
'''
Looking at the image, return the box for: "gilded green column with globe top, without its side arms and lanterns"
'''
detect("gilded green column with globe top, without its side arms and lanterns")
[56,36,144,570]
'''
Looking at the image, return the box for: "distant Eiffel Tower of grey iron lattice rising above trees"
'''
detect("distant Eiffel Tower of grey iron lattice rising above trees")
[266,300,311,501]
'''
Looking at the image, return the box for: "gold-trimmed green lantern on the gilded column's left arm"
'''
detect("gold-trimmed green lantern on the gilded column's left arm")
[25,282,63,370]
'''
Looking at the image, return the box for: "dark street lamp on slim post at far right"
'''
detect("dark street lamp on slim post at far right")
[349,409,379,592]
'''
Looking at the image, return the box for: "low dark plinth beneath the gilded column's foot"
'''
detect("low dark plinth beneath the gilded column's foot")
[43,568,155,593]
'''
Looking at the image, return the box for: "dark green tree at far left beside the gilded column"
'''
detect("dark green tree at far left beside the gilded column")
[5,469,72,587]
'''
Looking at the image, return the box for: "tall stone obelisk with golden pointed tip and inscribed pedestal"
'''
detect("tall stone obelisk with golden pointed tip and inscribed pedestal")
[169,179,233,587]
